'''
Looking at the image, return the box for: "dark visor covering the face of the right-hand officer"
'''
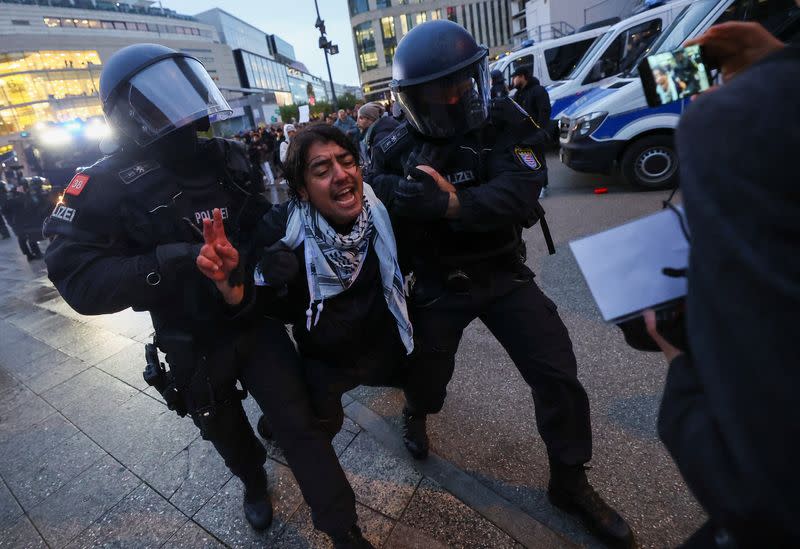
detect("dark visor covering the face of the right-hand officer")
[395,57,491,137]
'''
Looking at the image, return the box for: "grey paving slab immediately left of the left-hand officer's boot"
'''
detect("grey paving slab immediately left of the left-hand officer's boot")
[142,436,232,516]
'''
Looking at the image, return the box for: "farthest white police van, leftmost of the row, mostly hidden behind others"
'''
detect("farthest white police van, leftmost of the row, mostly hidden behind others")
[489,26,609,86]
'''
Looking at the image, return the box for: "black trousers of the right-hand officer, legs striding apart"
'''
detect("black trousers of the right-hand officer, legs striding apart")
[406,266,592,465]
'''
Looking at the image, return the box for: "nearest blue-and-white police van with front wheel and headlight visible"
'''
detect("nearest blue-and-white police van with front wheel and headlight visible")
[559,0,800,189]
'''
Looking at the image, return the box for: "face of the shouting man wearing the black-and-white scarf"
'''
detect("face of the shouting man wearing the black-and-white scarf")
[298,142,364,227]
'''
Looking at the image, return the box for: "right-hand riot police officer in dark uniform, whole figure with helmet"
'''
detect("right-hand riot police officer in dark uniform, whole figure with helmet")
[368,21,633,546]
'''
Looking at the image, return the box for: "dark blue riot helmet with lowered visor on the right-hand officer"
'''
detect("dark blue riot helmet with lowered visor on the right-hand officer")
[390,20,490,137]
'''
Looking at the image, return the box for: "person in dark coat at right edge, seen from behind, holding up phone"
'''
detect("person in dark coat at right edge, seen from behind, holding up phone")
[646,22,800,548]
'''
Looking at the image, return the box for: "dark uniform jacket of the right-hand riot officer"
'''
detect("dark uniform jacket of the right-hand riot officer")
[366,99,547,270]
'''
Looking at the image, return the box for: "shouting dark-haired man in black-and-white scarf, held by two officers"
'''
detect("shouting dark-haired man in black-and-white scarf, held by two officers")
[198,124,413,549]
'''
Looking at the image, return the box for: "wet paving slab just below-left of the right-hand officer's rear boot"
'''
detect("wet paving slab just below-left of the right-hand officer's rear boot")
[340,433,422,519]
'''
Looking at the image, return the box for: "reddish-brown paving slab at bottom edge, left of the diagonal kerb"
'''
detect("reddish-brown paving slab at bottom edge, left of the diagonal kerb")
[400,478,516,549]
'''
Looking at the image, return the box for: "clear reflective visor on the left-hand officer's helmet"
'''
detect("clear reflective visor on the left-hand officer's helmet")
[107,56,233,147]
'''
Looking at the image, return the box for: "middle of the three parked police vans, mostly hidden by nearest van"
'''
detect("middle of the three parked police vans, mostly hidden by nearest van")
[547,0,692,116]
